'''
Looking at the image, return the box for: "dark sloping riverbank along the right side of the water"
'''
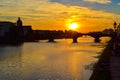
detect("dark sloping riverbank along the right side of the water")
[89,39,114,80]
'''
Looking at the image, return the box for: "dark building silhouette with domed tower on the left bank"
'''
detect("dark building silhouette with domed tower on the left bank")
[0,17,33,44]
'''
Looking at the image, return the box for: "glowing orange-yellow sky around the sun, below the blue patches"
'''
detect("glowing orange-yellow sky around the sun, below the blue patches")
[0,0,120,32]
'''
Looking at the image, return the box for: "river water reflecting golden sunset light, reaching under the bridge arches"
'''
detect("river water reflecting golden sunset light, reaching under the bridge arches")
[0,37,109,80]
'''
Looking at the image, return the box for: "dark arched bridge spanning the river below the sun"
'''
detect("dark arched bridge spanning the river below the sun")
[34,31,113,43]
